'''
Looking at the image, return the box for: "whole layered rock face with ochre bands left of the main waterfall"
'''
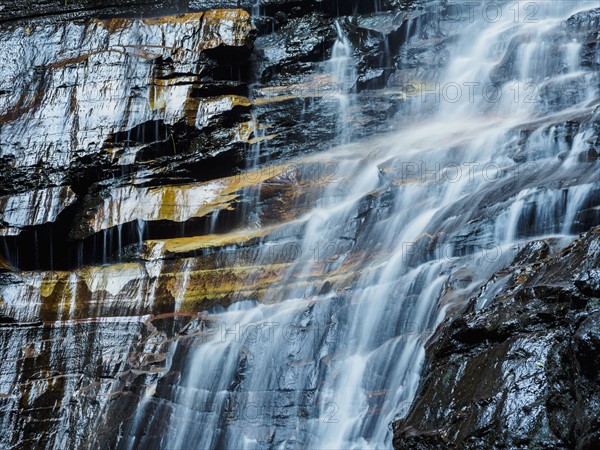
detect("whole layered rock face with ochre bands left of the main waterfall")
[0,0,424,448]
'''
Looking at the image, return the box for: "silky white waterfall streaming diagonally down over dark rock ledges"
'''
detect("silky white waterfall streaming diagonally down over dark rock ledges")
[120,1,599,449]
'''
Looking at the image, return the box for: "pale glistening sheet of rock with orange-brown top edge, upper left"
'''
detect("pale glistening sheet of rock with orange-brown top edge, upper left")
[0,10,252,193]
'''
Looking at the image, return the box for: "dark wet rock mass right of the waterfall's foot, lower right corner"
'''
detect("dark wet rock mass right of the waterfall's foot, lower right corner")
[394,228,600,449]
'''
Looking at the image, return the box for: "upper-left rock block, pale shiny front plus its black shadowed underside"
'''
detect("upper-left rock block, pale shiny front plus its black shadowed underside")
[0,8,254,265]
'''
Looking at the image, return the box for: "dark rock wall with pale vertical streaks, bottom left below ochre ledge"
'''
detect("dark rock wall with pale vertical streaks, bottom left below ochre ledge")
[0,321,141,448]
